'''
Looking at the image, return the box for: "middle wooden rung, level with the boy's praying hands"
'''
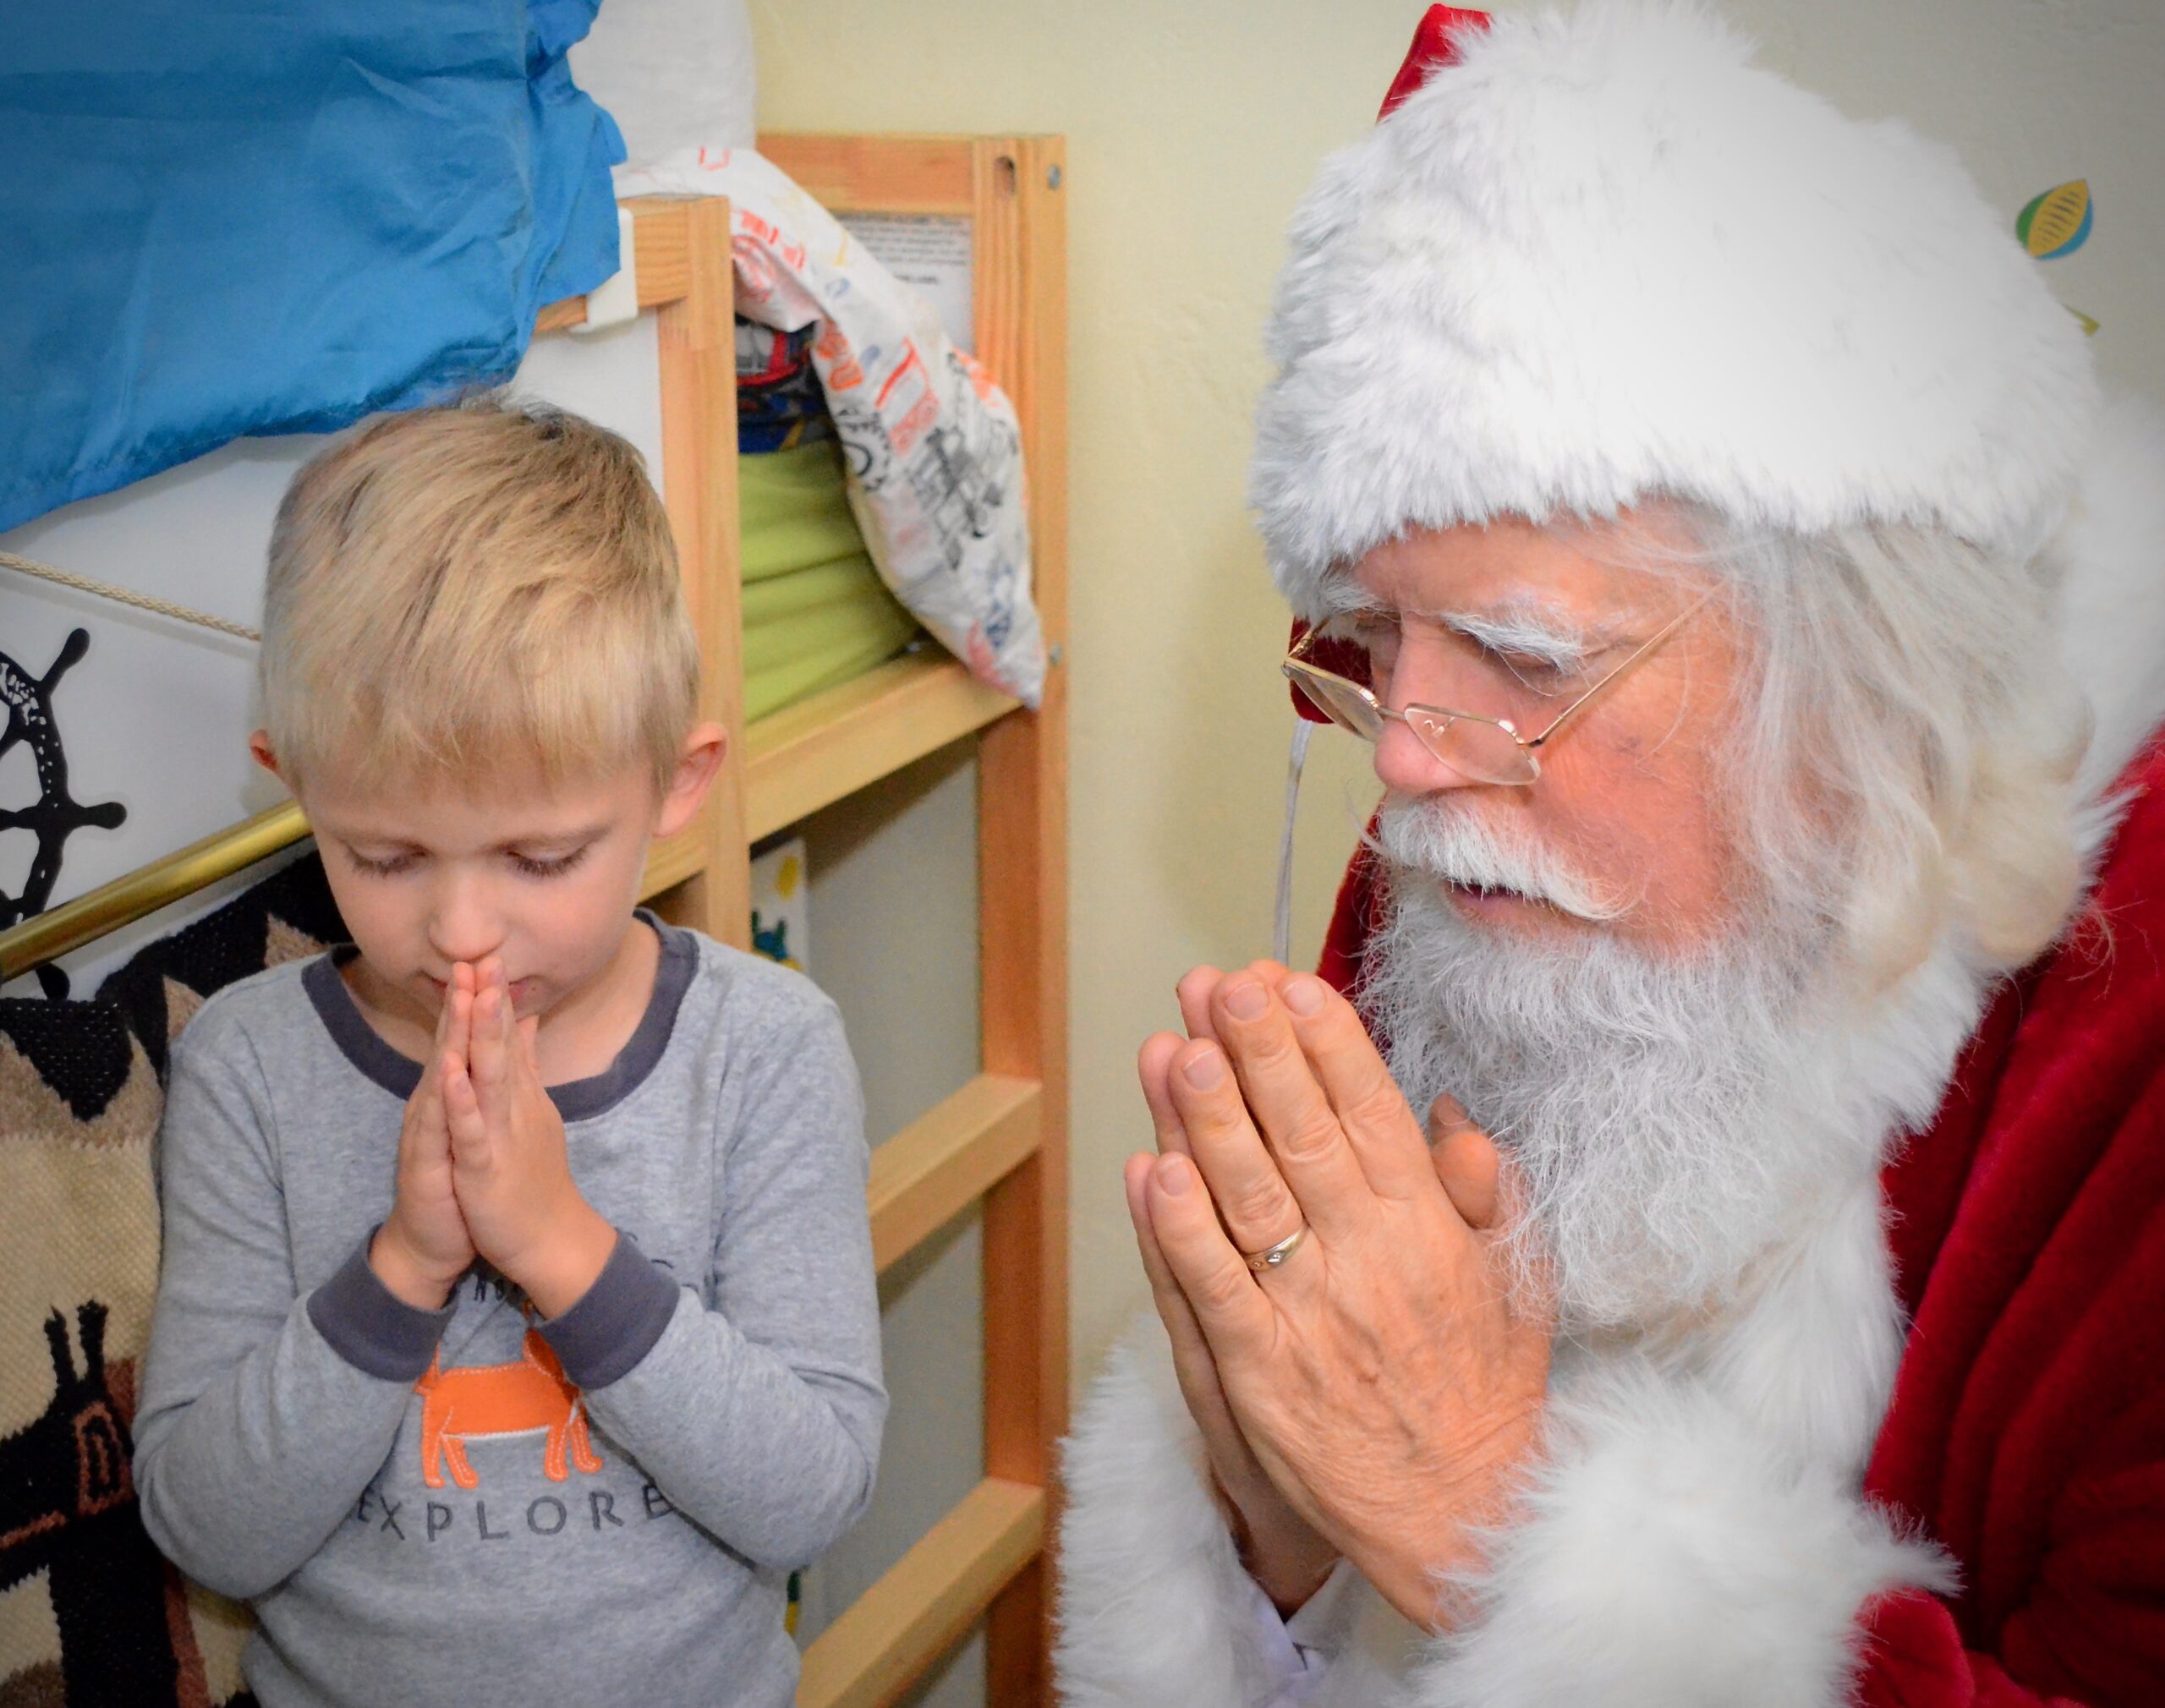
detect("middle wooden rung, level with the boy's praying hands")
[869,1074,1044,1271]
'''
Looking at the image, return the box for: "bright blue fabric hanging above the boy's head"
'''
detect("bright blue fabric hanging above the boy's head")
[0,0,623,530]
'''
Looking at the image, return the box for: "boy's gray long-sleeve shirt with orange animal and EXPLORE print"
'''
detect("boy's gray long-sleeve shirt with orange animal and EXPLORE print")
[134,916,885,1708]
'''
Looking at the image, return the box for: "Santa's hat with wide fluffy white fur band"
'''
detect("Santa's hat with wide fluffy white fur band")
[1252,0,2100,610]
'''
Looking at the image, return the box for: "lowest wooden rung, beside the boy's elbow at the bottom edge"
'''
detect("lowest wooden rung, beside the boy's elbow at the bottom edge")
[797,1476,1045,1708]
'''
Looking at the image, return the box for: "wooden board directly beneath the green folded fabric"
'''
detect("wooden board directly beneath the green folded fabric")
[743,648,1017,842]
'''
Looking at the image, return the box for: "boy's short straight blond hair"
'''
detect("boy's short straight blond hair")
[260,394,699,788]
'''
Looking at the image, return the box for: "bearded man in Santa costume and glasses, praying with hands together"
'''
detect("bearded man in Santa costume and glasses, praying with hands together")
[1059,0,2165,1708]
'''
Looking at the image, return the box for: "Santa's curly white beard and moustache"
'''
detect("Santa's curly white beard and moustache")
[1360,801,1871,1333]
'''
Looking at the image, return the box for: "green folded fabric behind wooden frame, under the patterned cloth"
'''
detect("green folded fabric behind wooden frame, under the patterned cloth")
[736,440,918,721]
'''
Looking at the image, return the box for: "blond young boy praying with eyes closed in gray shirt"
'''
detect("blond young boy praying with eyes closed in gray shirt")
[134,401,885,1708]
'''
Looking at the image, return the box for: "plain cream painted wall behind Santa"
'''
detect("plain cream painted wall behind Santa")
[754,0,2165,1394]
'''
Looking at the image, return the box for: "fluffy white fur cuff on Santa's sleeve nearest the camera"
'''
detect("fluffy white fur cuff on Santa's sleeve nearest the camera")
[1407,1366,1953,1708]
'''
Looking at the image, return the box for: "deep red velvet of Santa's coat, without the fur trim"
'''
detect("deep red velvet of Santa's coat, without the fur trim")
[1321,741,2165,1708]
